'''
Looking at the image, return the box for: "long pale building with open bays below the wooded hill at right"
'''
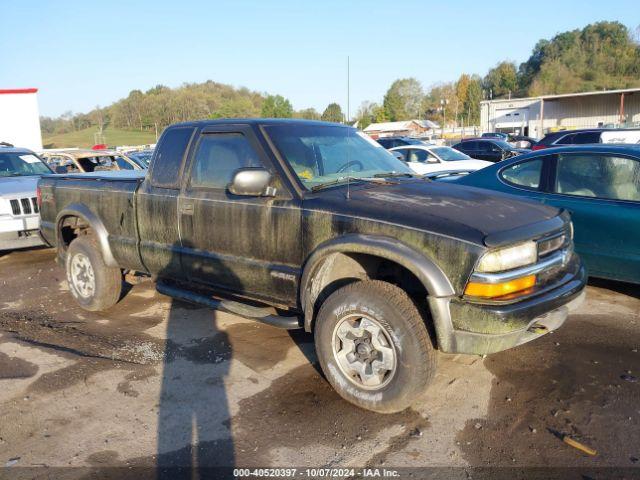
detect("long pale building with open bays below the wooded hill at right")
[480,88,640,138]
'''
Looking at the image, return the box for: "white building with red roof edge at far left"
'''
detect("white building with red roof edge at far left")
[0,88,42,150]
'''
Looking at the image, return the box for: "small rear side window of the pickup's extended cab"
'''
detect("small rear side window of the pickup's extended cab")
[151,127,194,188]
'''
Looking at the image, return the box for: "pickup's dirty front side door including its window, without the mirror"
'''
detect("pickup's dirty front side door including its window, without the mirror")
[178,126,301,305]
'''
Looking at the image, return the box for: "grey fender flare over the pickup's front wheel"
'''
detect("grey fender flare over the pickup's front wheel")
[299,234,455,331]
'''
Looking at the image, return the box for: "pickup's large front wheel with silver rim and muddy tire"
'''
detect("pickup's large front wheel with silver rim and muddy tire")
[314,280,437,413]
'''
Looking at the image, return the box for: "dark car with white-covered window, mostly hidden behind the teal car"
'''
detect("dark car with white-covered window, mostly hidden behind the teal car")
[533,128,640,150]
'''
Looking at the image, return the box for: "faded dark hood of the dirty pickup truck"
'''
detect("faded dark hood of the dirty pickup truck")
[313,179,559,245]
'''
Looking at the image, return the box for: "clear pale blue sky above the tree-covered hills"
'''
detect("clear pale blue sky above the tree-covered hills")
[0,0,640,116]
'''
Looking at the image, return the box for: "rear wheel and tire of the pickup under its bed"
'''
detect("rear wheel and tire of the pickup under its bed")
[65,235,122,312]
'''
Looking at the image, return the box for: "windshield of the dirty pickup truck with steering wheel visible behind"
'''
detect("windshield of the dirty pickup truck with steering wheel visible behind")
[265,125,413,189]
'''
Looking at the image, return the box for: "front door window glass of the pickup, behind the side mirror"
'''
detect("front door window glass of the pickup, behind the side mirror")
[191,133,262,188]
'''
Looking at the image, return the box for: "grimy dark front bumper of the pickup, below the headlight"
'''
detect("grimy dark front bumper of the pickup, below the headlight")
[429,259,587,355]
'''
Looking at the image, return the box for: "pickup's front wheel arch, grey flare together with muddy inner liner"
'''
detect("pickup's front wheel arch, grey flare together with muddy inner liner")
[299,234,455,331]
